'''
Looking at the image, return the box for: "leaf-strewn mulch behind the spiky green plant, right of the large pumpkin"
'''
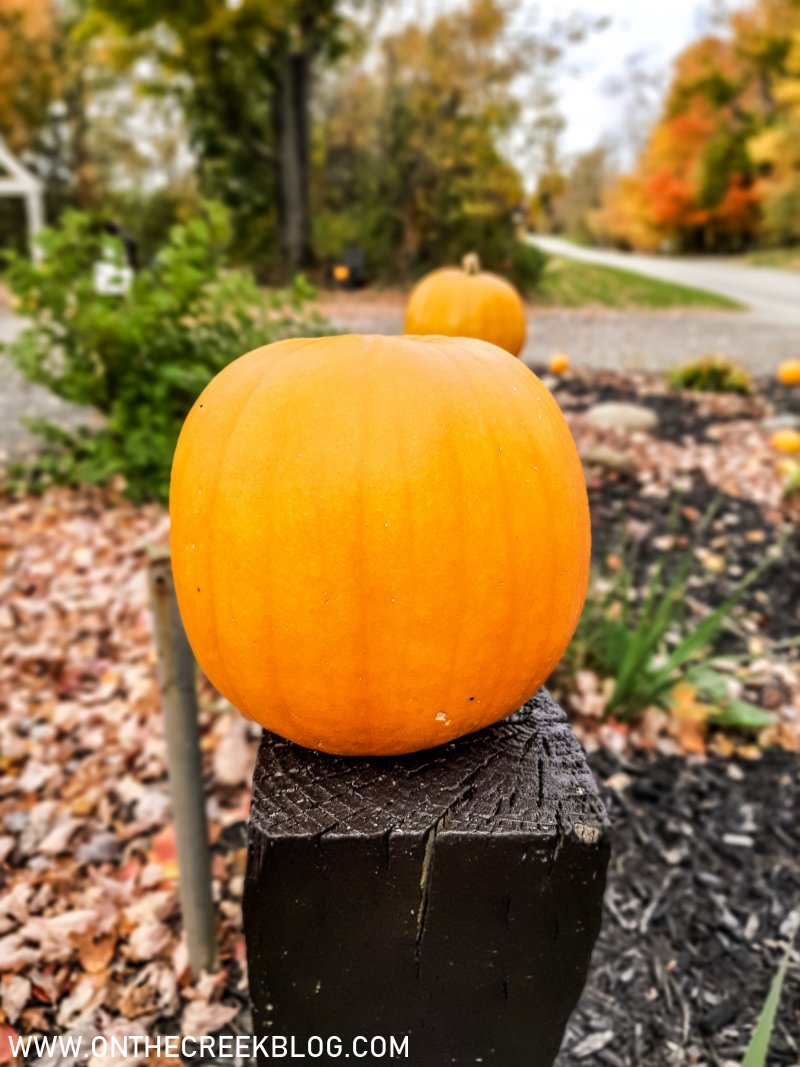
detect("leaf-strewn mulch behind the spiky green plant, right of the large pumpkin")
[539,369,800,754]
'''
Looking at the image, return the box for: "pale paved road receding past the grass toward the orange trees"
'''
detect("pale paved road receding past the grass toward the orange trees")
[530,235,800,327]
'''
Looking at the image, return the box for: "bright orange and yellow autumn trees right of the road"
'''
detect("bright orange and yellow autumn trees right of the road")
[601,0,800,249]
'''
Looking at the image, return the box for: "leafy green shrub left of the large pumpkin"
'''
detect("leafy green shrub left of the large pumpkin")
[6,204,326,500]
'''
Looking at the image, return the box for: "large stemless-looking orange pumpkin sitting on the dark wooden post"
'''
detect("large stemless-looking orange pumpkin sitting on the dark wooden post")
[170,336,590,755]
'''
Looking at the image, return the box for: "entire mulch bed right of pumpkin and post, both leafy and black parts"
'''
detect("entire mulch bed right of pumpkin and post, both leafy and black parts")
[556,372,800,1067]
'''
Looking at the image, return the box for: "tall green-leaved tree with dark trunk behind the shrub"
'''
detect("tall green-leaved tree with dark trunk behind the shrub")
[83,0,354,269]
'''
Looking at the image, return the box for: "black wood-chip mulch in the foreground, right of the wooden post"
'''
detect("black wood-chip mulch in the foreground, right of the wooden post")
[558,751,800,1067]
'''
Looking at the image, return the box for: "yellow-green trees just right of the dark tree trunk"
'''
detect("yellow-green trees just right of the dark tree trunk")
[313,0,540,282]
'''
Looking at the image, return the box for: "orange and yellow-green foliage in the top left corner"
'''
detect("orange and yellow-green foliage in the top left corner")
[0,0,197,251]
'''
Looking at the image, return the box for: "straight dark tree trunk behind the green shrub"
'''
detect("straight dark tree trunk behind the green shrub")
[274,45,311,270]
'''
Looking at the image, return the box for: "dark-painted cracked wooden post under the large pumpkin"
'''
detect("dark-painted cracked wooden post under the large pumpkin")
[244,690,609,1067]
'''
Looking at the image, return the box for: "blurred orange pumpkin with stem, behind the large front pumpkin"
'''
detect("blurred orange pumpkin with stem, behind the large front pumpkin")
[405,255,526,355]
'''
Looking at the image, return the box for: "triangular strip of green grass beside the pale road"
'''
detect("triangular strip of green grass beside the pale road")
[534,256,740,310]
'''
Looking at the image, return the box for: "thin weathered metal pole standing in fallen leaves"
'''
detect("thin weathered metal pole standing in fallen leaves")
[147,556,218,976]
